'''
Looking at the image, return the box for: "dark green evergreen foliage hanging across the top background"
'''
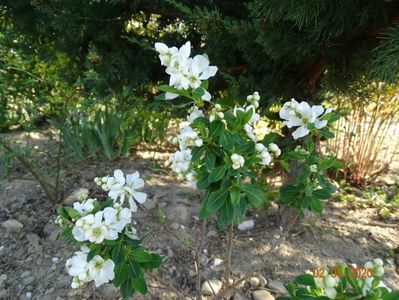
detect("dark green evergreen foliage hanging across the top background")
[0,0,399,126]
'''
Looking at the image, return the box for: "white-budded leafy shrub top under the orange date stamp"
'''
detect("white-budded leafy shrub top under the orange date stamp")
[277,258,399,300]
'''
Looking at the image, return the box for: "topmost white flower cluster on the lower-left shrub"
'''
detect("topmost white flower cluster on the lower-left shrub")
[94,170,147,212]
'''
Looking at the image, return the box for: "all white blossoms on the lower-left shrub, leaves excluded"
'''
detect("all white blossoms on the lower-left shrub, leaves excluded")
[63,170,147,288]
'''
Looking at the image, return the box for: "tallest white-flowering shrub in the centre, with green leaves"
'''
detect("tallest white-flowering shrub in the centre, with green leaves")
[155,42,338,228]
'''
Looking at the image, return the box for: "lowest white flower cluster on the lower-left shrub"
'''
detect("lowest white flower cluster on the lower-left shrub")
[66,247,115,289]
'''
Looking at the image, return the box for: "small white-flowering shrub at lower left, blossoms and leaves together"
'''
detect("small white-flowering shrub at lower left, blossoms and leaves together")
[56,170,162,298]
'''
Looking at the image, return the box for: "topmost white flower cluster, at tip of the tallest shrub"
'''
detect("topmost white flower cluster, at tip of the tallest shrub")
[155,42,218,101]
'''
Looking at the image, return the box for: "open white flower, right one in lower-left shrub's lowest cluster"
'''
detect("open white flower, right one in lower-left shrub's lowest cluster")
[88,255,115,287]
